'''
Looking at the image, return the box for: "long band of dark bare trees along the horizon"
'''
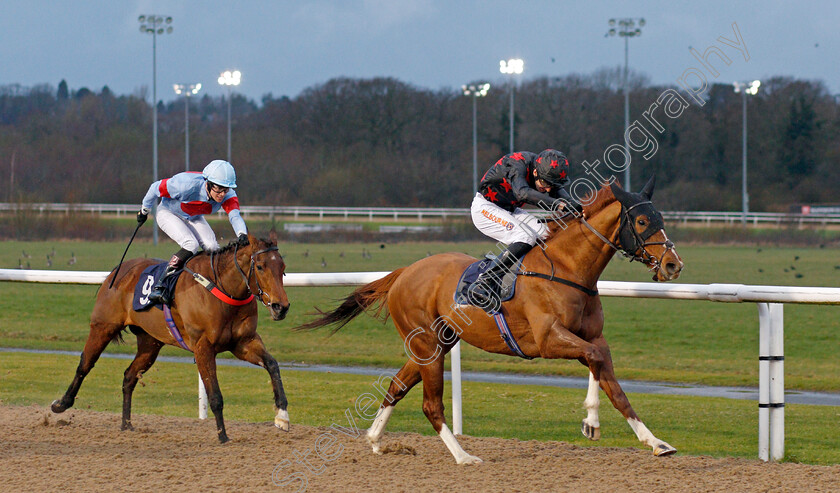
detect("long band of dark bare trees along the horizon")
[0,69,840,211]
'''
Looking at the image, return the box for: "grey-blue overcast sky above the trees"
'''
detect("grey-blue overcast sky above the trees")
[0,0,840,102]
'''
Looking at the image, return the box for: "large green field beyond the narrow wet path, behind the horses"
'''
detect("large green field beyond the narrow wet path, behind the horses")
[0,240,840,392]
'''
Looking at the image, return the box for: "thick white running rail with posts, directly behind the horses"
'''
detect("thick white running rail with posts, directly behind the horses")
[0,269,840,461]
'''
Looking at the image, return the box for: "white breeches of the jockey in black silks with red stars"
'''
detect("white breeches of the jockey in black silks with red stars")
[470,193,548,246]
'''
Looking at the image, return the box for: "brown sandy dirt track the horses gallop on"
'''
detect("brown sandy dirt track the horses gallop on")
[0,405,840,493]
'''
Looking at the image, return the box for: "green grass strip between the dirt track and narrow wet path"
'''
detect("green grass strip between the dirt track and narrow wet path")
[0,353,840,464]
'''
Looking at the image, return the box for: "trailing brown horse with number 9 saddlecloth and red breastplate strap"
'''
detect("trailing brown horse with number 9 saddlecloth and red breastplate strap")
[51,231,289,443]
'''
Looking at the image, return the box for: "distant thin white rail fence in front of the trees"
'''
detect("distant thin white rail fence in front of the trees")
[0,203,840,226]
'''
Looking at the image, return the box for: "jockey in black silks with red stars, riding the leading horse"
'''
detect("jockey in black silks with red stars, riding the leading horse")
[470,149,582,307]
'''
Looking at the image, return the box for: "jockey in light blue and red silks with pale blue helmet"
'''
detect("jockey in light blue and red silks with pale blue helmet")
[137,159,248,304]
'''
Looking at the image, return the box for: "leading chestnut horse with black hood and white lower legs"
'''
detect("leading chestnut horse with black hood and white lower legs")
[296,177,683,464]
